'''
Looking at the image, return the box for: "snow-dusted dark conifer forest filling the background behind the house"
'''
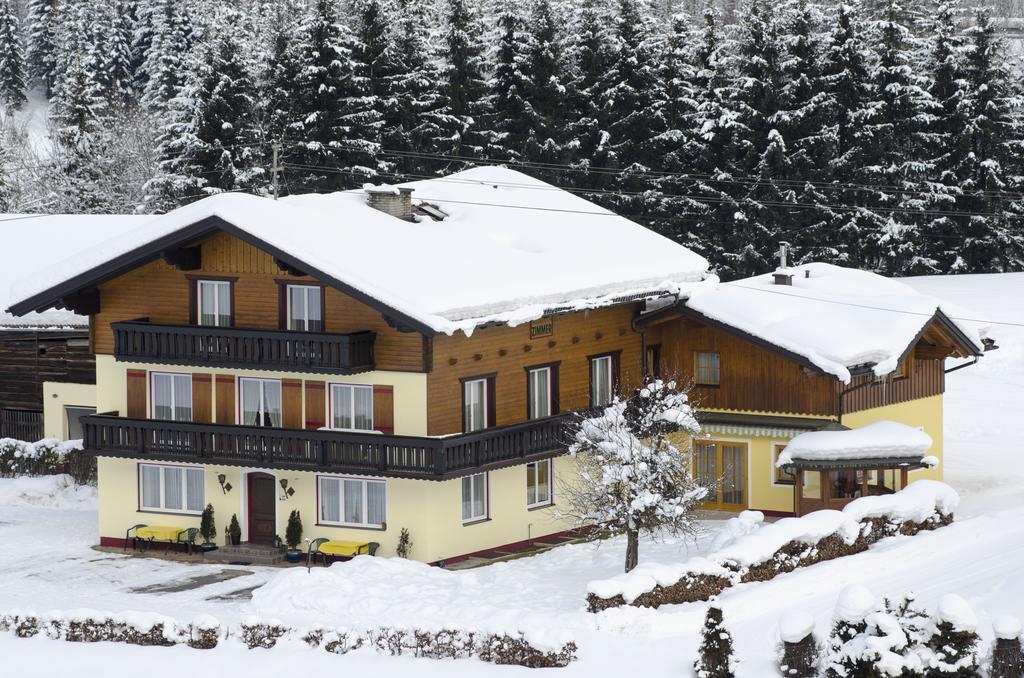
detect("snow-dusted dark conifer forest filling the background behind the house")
[0,0,1024,279]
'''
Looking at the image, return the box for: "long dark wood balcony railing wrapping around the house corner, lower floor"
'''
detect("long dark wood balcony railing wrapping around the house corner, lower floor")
[81,415,572,480]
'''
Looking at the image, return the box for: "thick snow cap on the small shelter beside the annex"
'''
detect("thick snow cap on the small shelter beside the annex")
[776,421,932,466]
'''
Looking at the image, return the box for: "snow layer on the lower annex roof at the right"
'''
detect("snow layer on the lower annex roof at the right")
[686,263,988,383]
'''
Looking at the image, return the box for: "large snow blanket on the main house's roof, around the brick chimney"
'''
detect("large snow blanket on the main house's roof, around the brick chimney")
[9,167,708,334]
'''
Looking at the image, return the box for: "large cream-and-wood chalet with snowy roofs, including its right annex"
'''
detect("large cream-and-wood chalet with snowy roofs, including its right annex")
[4,167,984,562]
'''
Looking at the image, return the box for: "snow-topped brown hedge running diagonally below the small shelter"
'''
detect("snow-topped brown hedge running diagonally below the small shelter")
[587,480,959,612]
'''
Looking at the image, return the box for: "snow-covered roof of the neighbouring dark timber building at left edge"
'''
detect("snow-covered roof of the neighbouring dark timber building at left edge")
[0,214,153,331]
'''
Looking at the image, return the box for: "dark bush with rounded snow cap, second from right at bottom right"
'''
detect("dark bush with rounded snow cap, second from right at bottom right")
[925,593,981,678]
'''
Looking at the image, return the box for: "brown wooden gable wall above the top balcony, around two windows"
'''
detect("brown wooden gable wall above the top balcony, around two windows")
[91,234,424,372]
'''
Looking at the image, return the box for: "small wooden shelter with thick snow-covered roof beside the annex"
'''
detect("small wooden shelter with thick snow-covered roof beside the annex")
[776,421,938,515]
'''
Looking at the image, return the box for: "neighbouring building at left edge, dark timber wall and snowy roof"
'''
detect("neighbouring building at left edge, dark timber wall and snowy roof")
[0,214,145,440]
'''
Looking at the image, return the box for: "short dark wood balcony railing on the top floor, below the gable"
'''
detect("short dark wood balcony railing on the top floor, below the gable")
[111,321,375,374]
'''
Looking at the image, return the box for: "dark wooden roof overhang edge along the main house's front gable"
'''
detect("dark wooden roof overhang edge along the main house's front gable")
[8,216,437,336]
